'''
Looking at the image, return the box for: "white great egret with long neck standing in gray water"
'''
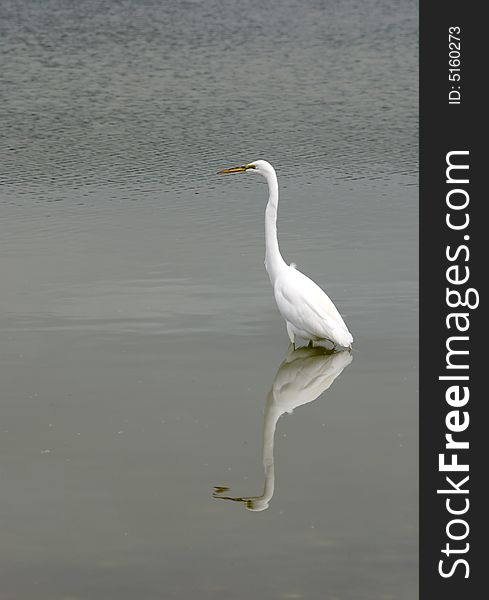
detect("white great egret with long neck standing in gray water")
[219,160,353,348]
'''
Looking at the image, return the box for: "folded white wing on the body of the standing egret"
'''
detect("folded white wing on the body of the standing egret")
[274,269,351,345]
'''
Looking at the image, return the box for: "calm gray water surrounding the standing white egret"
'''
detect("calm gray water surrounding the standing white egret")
[0,0,418,600]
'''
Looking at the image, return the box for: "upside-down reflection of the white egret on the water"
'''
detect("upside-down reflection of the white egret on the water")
[212,345,352,512]
